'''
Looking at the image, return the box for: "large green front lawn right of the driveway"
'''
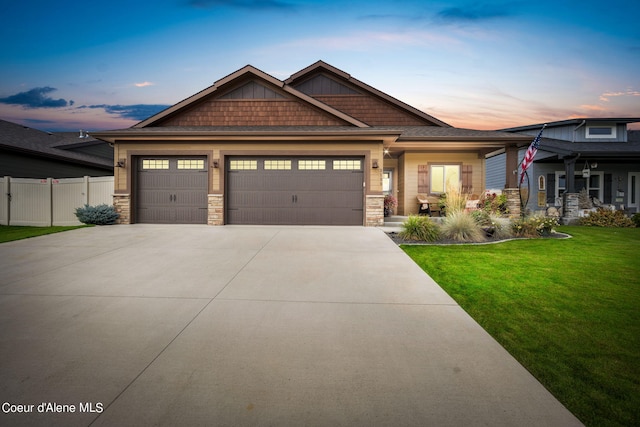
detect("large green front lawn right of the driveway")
[402,226,640,426]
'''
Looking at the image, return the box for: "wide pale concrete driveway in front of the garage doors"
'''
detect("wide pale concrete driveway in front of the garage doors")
[0,225,580,426]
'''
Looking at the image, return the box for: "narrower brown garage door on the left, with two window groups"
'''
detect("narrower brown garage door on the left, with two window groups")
[135,157,208,224]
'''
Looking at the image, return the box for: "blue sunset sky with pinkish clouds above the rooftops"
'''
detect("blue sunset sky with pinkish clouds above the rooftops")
[0,0,640,131]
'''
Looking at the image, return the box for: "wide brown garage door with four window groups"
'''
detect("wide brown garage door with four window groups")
[226,157,364,225]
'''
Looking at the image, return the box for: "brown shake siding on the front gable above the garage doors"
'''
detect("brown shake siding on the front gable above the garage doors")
[158,99,347,126]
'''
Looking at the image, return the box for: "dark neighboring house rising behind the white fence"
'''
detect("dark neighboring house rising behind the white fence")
[0,120,113,178]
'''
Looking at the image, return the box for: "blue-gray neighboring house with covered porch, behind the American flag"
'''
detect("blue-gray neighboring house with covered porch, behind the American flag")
[486,118,640,213]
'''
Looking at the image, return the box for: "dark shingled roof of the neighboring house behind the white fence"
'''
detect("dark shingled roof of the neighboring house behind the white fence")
[0,120,113,170]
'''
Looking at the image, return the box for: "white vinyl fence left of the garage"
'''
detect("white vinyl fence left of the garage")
[0,176,113,227]
